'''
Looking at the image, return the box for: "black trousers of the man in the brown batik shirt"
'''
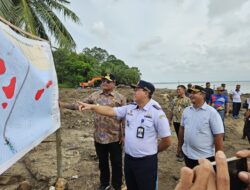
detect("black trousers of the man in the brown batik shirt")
[95,142,122,189]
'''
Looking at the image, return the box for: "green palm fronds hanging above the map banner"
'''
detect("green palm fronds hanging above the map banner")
[0,0,80,49]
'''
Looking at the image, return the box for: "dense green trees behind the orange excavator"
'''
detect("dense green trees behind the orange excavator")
[53,47,141,87]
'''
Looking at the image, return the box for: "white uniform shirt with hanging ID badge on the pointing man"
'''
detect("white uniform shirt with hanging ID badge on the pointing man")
[114,99,171,158]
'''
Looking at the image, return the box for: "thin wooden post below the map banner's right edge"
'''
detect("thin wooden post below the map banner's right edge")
[56,128,62,178]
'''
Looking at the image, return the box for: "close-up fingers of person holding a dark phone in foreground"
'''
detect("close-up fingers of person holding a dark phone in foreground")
[175,150,250,190]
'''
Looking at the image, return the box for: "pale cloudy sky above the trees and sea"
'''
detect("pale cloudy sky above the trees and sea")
[62,0,250,82]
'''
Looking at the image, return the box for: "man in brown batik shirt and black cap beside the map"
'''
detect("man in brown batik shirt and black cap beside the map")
[60,74,126,190]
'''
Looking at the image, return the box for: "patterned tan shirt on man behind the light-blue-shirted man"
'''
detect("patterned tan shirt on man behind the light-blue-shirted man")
[170,96,191,123]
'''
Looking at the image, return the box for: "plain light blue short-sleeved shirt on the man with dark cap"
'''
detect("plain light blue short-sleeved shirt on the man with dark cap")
[181,102,224,160]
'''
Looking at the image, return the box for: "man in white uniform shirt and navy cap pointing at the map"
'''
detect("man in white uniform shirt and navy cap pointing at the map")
[79,80,171,190]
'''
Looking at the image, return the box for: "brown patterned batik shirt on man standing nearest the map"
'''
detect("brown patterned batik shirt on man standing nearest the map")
[84,91,126,144]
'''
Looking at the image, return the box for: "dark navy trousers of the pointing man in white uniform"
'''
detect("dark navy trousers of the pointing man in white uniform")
[124,154,157,190]
